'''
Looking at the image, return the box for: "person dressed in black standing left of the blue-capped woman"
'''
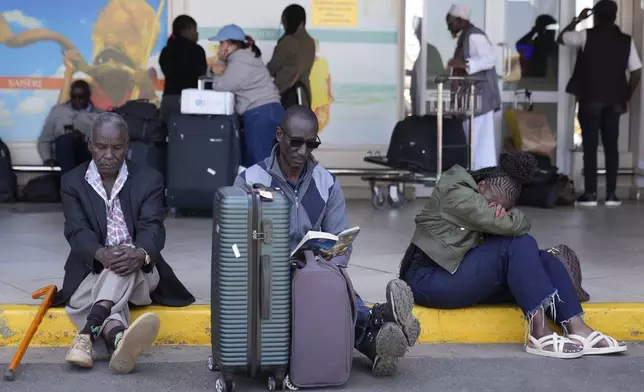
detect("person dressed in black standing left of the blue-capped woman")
[159,15,208,122]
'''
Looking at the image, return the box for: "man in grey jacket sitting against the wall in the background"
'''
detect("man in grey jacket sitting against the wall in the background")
[38,80,100,173]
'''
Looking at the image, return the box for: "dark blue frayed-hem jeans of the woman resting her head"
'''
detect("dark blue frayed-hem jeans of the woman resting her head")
[406,234,583,324]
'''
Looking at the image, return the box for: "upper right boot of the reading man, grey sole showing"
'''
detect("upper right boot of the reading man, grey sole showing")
[371,279,420,347]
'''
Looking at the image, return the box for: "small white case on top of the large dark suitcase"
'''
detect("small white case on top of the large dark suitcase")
[181,78,235,116]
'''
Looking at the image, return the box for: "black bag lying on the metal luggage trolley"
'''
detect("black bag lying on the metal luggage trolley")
[387,115,469,173]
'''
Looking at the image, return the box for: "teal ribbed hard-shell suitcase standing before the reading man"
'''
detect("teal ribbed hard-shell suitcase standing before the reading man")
[209,187,291,392]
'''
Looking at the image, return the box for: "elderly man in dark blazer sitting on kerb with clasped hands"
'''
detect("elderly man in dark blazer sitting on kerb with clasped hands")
[54,113,195,373]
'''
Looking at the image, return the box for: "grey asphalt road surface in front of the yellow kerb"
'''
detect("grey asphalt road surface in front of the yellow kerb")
[0,344,644,392]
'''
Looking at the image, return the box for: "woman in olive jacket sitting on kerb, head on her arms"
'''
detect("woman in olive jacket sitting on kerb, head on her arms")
[399,152,626,358]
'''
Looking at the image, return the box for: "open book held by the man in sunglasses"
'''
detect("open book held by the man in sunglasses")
[291,226,360,260]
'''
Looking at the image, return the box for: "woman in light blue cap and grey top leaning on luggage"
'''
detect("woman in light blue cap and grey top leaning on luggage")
[209,24,284,167]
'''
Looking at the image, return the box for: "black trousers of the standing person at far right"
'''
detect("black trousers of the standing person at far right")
[577,102,622,193]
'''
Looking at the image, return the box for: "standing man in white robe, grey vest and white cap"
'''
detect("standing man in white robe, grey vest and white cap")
[446,5,501,170]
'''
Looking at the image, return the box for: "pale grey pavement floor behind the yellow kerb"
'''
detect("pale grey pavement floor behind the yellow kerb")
[0,200,644,303]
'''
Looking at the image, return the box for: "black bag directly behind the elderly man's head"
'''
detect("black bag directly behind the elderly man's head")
[112,99,167,142]
